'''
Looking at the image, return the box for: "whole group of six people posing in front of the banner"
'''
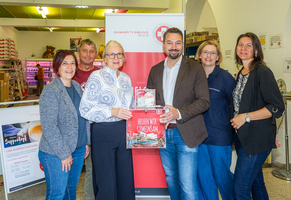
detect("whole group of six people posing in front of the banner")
[39,28,284,200]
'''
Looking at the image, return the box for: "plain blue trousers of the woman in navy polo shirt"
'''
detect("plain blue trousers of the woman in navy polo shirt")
[198,144,234,200]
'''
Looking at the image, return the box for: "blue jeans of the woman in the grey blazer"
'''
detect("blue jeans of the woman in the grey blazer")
[38,146,85,200]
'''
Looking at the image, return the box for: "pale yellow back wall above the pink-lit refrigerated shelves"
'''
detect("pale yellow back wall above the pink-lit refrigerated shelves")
[18,31,105,60]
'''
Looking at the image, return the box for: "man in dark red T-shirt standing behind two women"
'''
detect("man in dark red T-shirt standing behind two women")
[73,39,99,200]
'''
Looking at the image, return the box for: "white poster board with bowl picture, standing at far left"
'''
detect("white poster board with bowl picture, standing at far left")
[0,106,45,198]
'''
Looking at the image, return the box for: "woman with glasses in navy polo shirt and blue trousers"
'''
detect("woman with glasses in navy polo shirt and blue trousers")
[196,40,234,200]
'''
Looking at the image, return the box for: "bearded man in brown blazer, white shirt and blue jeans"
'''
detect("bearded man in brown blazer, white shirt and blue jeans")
[147,28,210,200]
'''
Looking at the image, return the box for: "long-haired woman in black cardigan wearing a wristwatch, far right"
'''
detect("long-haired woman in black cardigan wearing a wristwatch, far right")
[230,33,284,200]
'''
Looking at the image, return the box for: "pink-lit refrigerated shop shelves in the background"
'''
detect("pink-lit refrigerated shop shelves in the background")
[25,58,104,88]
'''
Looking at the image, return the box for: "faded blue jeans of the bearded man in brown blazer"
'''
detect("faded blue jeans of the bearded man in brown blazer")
[160,128,198,200]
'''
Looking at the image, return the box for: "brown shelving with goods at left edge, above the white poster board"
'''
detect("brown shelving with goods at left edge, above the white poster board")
[0,59,27,102]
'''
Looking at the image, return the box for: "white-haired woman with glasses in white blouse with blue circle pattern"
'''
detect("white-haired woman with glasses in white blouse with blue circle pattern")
[80,40,135,200]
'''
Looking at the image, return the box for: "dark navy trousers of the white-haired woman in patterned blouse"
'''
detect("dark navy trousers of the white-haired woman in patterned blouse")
[91,120,135,200]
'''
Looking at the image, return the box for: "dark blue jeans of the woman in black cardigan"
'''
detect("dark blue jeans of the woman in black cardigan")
[233,135,271,200]
